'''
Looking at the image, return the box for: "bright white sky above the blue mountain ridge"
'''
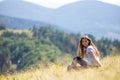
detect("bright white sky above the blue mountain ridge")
[0,0,120,8]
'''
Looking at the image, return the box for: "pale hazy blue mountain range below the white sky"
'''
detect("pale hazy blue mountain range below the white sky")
[0,0,120,37]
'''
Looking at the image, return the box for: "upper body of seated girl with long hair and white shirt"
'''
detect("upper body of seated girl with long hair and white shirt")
[77,36,102,67]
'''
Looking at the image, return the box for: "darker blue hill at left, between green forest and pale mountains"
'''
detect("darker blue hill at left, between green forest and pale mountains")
[0,15,50,29]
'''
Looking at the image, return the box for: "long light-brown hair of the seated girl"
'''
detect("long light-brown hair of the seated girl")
[77,36,101,58]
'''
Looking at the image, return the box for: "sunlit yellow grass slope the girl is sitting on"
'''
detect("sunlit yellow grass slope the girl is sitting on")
[0,55,120,80]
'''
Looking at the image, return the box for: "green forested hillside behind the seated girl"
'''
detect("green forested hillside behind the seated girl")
[0,27,120,74]
